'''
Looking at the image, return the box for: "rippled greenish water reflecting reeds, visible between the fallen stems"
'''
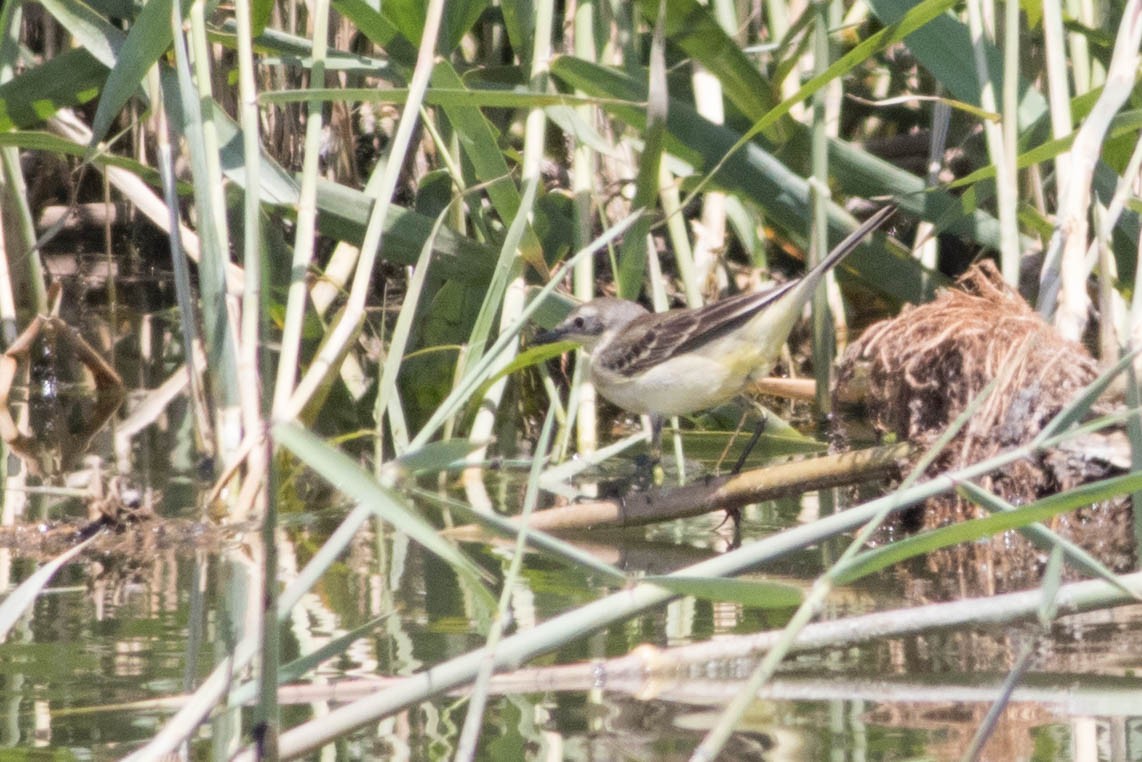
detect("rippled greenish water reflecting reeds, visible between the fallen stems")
[0,488,1142,760]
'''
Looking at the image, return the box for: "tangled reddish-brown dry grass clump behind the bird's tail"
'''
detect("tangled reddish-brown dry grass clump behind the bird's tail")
[835,262,1133,589]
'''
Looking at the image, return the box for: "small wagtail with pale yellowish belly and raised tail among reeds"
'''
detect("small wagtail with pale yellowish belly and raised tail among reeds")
[536,206,895,417]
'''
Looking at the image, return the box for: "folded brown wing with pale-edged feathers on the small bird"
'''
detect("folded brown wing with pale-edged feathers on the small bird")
[593,281,797,376]
